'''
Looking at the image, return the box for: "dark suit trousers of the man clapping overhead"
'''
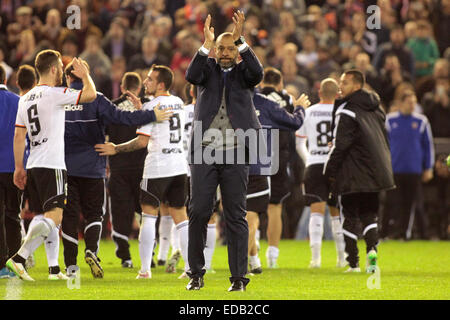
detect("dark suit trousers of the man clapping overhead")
[188,164,249,284]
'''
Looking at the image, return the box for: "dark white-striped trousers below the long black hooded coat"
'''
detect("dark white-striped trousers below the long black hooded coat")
[340,192,379,268]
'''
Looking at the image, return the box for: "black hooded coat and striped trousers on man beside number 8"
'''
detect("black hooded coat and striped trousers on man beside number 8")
[324,90,394,268]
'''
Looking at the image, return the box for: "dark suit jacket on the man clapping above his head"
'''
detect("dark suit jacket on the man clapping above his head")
[186,48,264,160]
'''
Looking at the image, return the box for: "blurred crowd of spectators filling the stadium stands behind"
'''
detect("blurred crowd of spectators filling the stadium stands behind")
[0,0,450,239]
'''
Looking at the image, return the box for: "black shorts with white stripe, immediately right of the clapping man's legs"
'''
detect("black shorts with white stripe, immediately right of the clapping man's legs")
[247,175,270,213]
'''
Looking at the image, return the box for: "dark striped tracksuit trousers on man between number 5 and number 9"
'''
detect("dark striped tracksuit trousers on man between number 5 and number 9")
[61,176,105,267]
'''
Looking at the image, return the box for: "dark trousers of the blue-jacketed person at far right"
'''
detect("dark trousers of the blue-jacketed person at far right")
[381,173,423,239]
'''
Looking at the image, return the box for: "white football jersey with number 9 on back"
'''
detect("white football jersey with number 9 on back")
[136,95,187,179]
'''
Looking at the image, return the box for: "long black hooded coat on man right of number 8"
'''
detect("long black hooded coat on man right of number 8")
[324,90,394,195]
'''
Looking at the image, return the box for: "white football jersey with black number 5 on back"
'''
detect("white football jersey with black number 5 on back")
[16,85,82,170]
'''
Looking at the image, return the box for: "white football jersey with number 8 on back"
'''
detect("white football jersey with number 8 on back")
[296,103,333,166]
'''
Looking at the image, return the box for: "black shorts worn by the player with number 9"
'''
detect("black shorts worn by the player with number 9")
[141,174,188,208]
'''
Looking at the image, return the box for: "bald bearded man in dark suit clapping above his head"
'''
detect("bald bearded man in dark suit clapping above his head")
[186,11,263,291]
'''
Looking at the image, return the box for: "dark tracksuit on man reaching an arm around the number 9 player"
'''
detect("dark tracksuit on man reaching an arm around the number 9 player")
[62,82,156,267]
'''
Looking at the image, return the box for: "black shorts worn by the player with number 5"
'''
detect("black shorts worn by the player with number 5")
[25,168,67,214]
